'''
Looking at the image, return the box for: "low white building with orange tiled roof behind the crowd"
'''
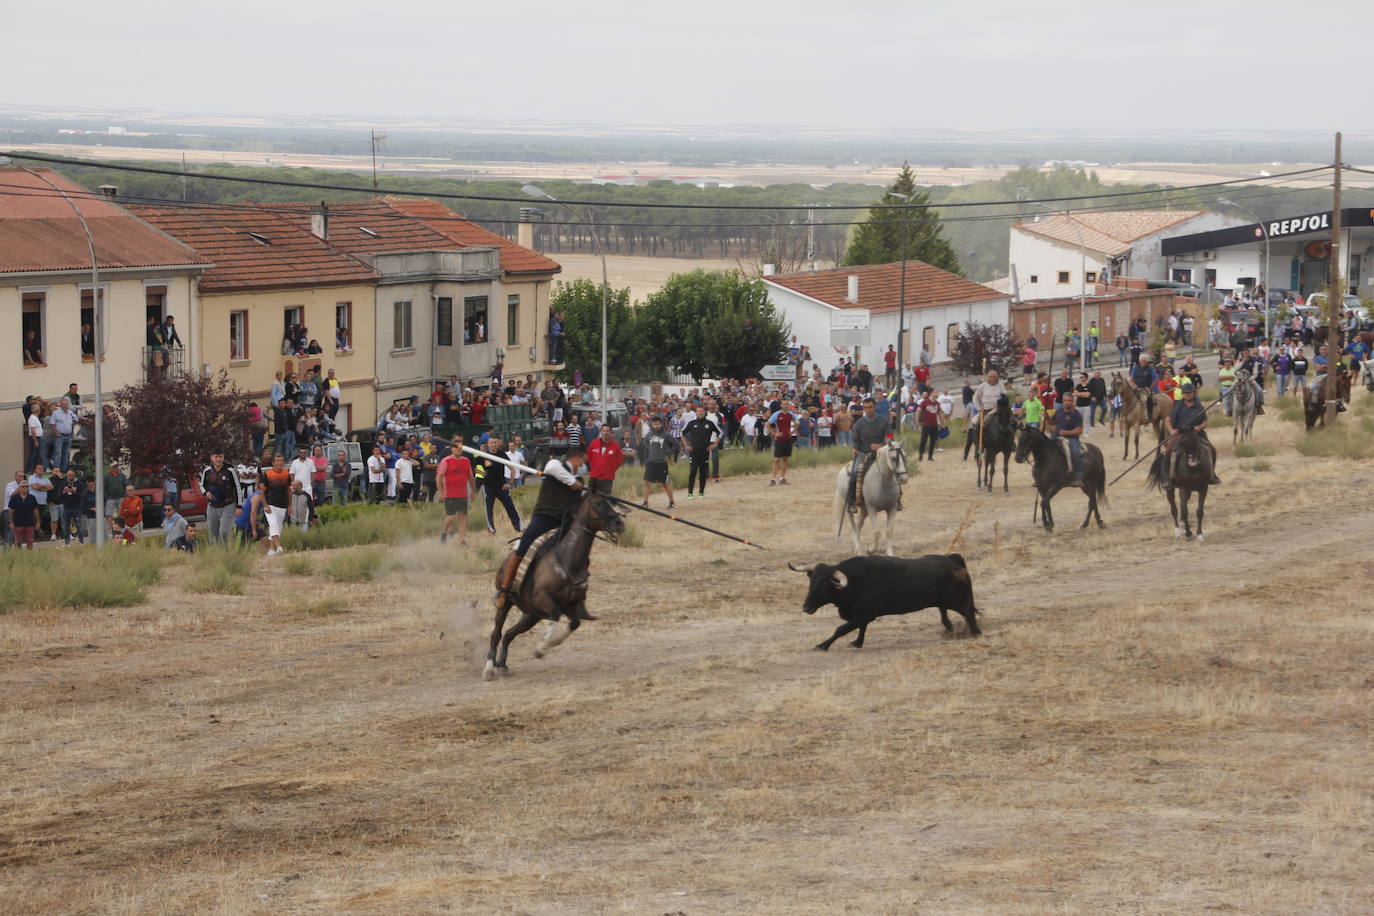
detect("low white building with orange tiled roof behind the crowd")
[764,261,1010,374]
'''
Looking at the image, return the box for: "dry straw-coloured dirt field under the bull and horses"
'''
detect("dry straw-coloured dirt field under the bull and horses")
[0,411,1374,915]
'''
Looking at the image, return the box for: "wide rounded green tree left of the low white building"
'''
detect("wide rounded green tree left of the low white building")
[639,271,790,379]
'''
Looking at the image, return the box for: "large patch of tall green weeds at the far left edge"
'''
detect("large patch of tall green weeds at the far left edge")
[0,538,172,612]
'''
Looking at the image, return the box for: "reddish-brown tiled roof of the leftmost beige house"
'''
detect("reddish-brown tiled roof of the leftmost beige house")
[0,169,206,273]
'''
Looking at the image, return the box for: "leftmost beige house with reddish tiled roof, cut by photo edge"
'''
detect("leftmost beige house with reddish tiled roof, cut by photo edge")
[0,168,207,477]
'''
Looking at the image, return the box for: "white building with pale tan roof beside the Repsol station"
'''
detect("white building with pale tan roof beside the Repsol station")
[1009,210,1245,299]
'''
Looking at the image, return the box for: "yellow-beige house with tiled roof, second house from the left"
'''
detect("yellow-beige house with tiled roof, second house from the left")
[129,206,379,428]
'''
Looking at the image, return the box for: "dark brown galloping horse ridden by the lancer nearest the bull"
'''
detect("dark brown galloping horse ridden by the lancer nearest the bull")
[482,493,625,681]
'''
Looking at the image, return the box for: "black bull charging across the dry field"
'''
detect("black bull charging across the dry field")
[787,553,982,652]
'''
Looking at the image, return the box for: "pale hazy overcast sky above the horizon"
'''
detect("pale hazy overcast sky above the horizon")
[0,0,1374,129]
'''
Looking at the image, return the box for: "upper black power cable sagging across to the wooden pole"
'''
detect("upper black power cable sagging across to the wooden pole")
[5,152,1331,210]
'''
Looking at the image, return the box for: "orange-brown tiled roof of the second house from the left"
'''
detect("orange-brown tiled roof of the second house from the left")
[129,206,378,293]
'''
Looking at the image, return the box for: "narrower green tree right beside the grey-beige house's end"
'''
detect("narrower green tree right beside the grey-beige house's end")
[548,280,644,385]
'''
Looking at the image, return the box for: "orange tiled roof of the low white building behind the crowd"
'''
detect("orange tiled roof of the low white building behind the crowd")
[764,261,1007,312]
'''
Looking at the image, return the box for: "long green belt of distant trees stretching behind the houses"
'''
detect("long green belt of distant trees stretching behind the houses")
[42,157,1374,280]
